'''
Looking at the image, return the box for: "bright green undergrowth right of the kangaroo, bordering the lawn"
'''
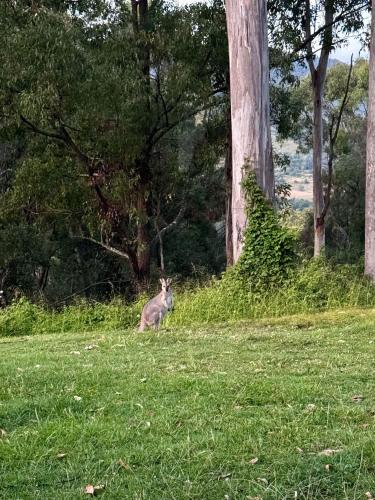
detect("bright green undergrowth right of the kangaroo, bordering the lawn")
[167,258,375,326]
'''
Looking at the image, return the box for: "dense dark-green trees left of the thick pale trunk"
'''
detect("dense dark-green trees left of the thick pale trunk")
[0,1,227,303]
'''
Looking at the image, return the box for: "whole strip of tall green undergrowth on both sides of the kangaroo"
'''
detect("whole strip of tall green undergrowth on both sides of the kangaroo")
[0,258,375,336]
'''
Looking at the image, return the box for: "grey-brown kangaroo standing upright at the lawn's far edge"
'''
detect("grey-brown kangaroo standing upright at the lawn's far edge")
[139,278,173,332]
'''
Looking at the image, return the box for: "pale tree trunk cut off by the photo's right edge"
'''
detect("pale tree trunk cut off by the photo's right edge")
[365,10,375,281]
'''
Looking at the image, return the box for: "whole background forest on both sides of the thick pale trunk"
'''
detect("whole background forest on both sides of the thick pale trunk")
[0,0,374,316]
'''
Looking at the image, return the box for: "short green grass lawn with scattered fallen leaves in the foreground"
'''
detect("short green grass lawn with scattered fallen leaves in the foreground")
[0,311,375,500]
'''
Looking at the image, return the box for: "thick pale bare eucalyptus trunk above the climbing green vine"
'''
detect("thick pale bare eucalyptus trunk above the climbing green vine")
[225,0,274,262]
